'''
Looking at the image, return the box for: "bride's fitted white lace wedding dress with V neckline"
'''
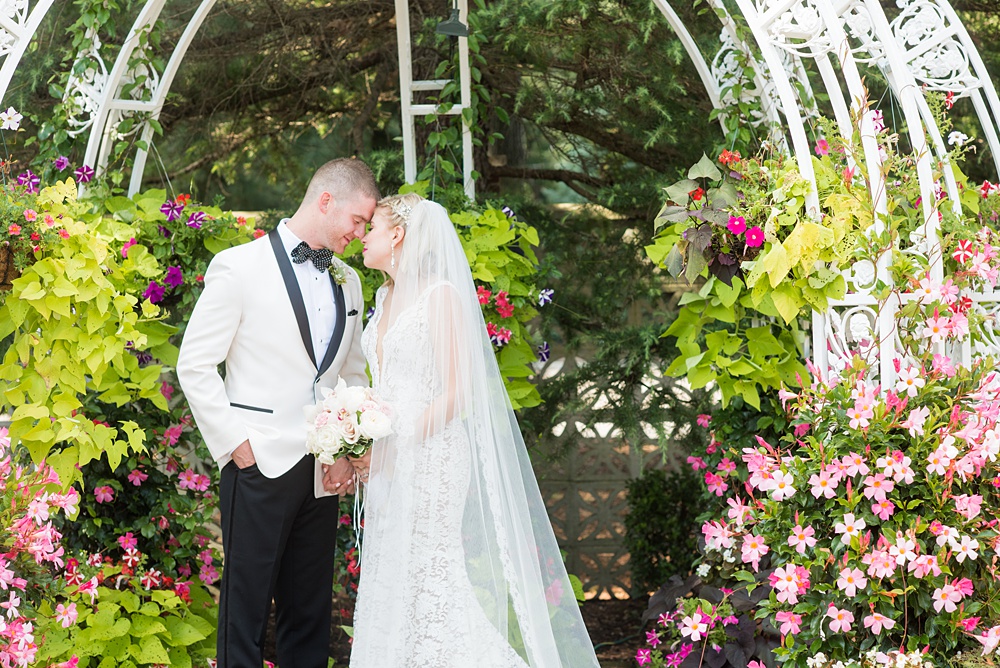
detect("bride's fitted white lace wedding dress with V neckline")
[350,284,537,668]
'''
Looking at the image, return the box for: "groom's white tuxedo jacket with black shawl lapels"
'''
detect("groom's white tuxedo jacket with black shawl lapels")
[177,232,368,478]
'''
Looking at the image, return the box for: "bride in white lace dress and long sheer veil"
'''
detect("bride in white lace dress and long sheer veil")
[350,194,598,668]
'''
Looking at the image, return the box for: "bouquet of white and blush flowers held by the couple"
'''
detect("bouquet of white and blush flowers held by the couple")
[305,378,392,464]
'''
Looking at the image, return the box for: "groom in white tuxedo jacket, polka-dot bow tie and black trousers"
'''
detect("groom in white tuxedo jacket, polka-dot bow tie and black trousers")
[177,159,379,668]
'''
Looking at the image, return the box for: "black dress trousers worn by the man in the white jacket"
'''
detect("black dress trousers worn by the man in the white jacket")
[218,455,339,668]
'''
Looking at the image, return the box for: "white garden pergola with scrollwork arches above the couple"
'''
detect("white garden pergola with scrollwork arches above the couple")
[0,0,1000,384]
